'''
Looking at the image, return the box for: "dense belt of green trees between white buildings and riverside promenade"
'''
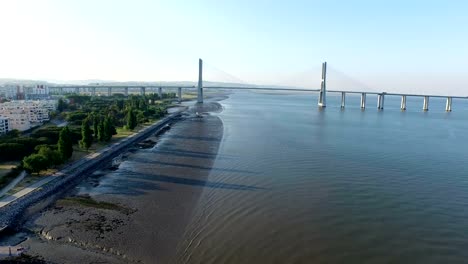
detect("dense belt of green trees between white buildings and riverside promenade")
[8,93,175,175]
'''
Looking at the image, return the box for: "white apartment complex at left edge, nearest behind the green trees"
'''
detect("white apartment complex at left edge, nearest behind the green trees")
[0,100,57,131]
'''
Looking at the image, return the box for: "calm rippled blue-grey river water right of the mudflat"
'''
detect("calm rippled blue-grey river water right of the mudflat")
[176,92,468,263]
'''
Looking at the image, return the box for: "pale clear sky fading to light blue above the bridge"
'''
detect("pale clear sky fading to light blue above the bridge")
[0,0,468,95]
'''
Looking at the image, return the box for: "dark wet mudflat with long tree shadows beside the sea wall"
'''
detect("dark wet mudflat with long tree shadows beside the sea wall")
[22,102,225,263]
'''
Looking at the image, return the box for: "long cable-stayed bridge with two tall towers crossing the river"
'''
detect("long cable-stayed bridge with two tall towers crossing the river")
[49,59,468,112]
